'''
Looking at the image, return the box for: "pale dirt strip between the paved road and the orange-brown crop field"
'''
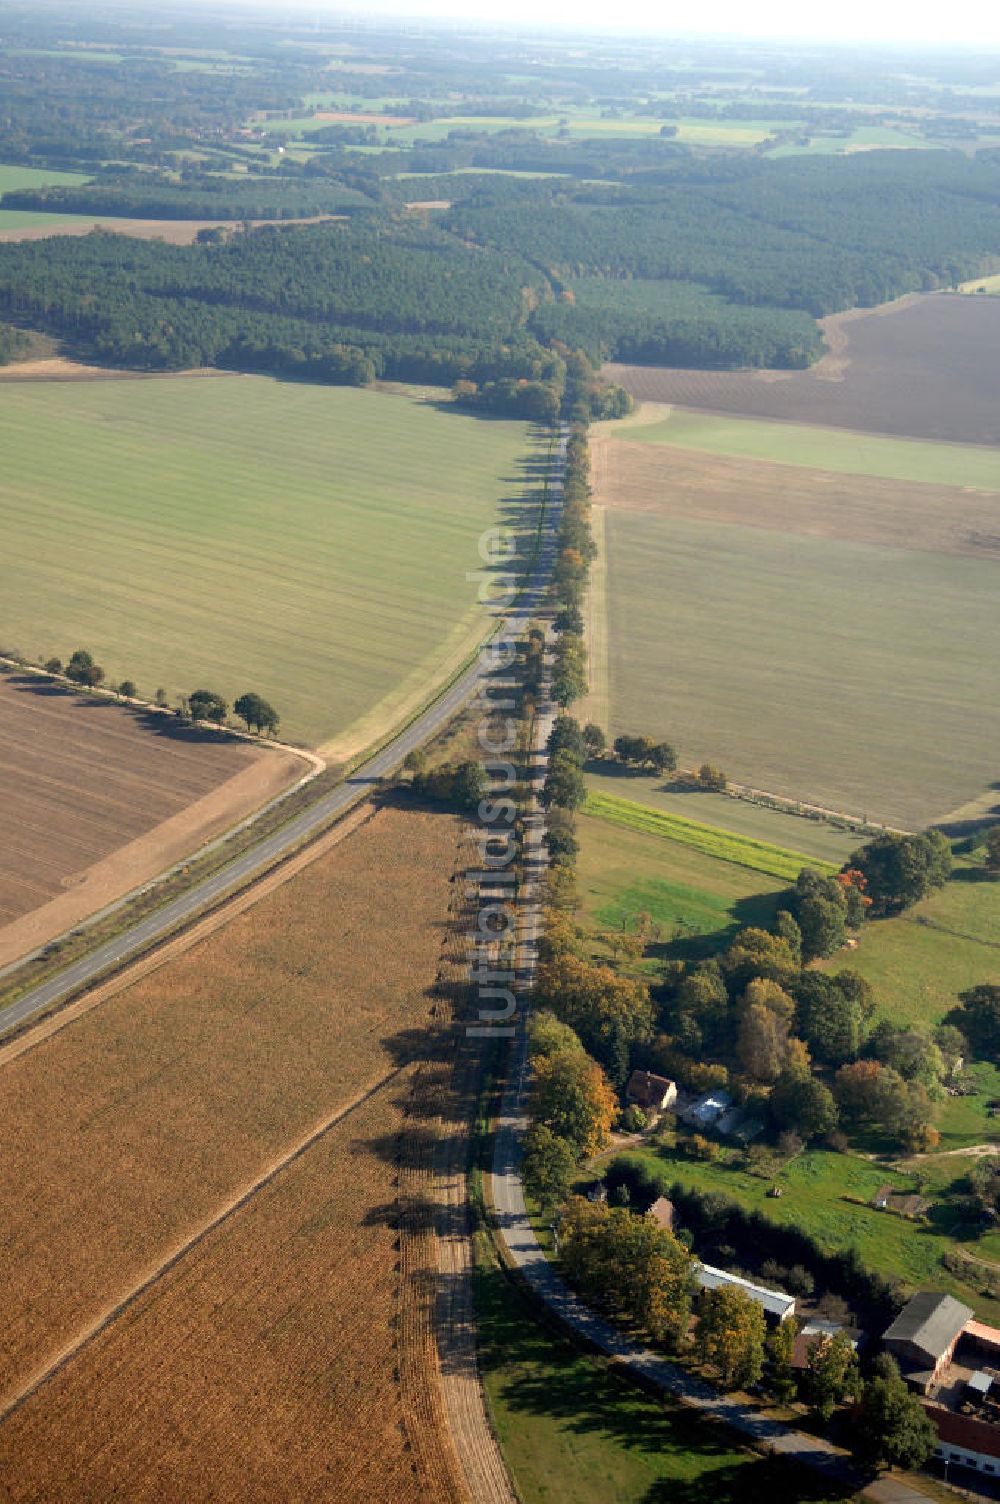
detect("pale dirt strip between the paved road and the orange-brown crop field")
[0,800,377,1069]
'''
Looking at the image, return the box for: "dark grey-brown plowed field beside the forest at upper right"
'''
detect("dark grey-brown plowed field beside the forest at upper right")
[606,293,1000,444]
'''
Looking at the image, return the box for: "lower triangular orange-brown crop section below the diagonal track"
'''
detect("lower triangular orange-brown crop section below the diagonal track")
[0,1080,465,1504]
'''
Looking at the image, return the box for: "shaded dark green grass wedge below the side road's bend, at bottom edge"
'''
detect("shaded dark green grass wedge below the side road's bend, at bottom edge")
[475,1260,848,1504]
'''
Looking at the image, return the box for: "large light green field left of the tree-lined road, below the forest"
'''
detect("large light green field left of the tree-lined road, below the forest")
[0,376,532,749]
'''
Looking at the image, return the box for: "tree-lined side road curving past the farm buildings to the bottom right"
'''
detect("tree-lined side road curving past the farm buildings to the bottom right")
[492,682,928,1504]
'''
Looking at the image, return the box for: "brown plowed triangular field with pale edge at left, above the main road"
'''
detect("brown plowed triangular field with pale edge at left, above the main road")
[0,674,300,966]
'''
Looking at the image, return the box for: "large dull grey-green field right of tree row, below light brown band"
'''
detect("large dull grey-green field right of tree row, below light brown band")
[605,508,1000,827]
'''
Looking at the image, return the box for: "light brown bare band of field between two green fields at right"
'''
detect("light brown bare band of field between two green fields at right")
[592,429,1000,559]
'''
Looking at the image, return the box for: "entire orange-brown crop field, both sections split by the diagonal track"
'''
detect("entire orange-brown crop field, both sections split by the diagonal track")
[0,809,460,1504]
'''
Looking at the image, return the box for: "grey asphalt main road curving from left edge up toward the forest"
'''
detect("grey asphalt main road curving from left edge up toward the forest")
[0,439,565,1035]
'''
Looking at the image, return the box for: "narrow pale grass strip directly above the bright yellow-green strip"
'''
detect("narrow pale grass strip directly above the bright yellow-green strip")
[586,763,863,868]
